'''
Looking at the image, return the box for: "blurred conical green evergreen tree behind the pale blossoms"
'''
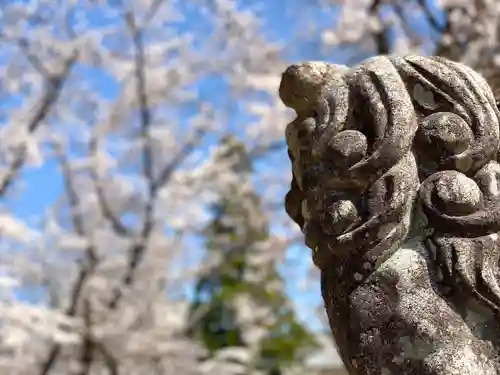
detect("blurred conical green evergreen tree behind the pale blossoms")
[191,136,317,375]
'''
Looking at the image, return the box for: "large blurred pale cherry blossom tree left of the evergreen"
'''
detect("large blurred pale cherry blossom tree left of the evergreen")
[0,0,296,375]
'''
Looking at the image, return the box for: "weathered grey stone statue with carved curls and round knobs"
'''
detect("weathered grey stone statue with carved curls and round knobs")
[280,56,500,375]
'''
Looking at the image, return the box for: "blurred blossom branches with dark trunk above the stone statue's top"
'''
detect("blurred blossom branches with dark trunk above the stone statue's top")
[313,0,500,79]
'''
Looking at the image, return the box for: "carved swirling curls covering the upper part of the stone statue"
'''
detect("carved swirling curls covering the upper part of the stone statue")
[280,56,500,306]
